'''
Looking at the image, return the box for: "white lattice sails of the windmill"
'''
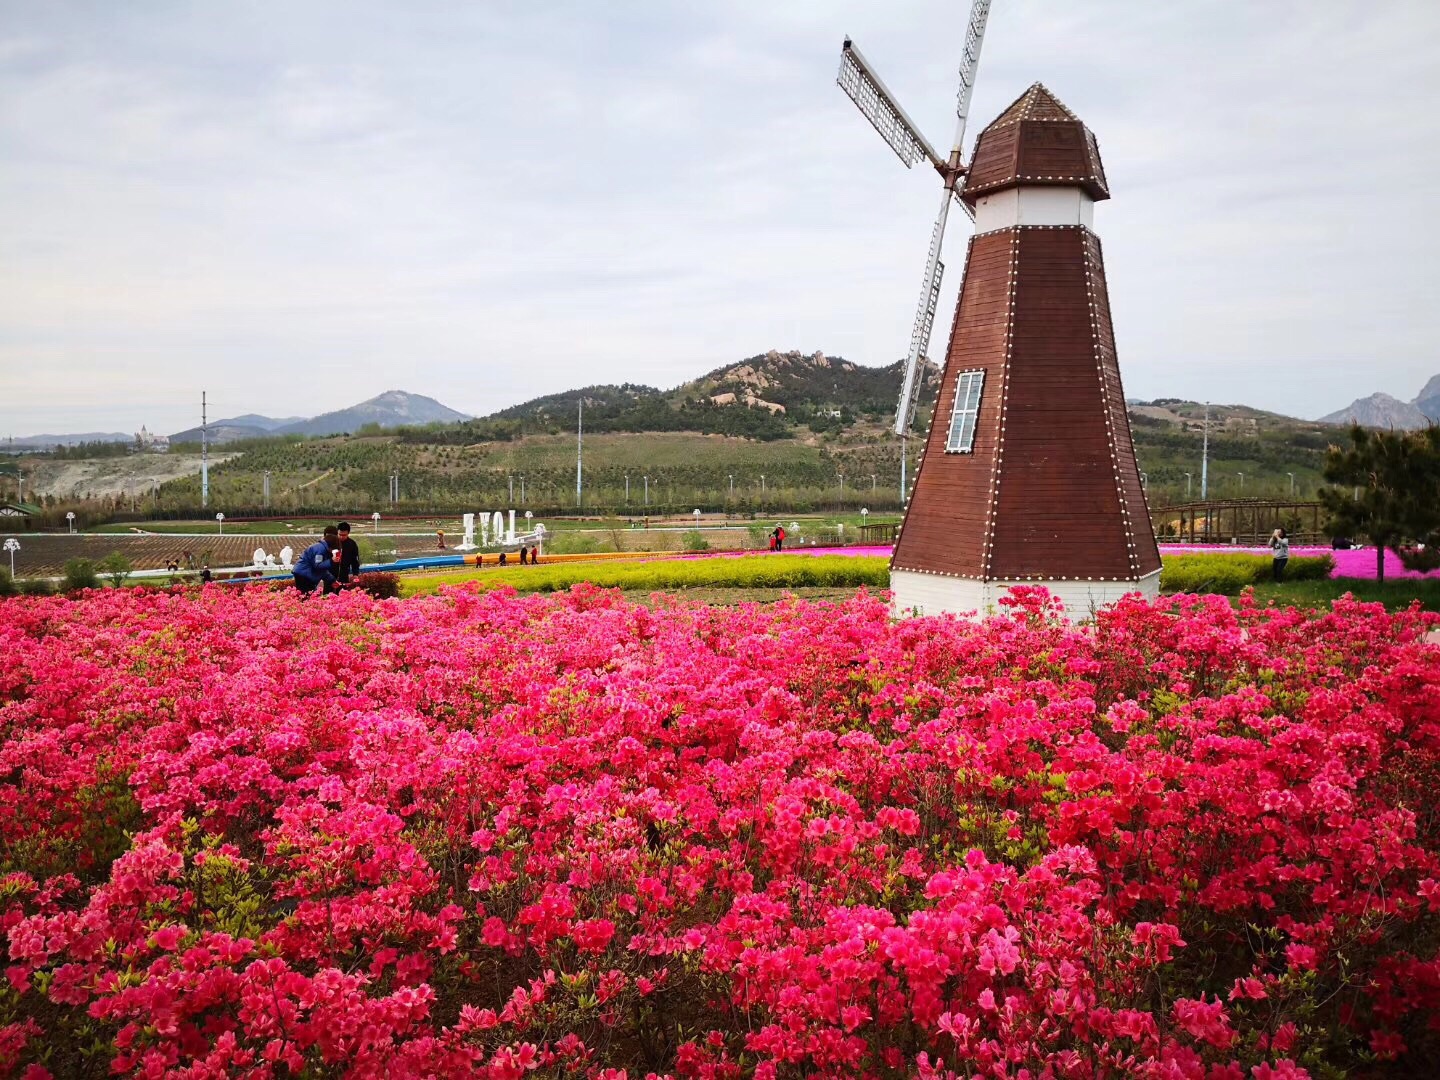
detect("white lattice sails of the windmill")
[835,0,991,504]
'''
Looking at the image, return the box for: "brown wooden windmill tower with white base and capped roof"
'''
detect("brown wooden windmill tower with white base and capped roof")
[847,10,1161,618]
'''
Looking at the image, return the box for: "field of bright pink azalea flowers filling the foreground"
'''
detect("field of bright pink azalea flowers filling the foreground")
[0,586,1440,1080]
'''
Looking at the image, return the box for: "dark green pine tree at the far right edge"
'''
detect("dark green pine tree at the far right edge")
[1320,425,1440,580]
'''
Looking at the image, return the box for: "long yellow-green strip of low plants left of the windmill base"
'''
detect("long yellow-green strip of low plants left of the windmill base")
[402,554,890,596]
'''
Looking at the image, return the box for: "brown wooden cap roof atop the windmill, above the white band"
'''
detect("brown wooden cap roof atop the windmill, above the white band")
[960,82,1110,206]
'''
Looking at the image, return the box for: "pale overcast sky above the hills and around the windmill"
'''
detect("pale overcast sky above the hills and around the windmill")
[0,0,1440,435]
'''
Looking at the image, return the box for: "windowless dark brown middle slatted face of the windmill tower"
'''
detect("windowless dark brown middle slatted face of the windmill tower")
[991,228,1132,580]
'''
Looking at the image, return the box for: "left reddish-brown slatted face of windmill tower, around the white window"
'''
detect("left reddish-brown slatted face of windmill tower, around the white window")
[891,229,1014,577]
